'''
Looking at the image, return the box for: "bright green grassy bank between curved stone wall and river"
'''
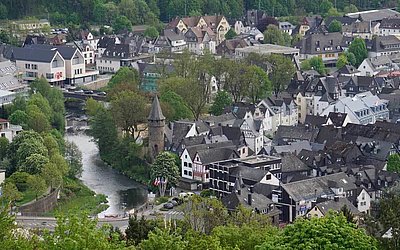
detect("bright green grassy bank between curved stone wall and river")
[49,179,108,215]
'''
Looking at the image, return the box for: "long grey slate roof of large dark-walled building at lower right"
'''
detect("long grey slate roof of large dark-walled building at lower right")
[282,173,357,201]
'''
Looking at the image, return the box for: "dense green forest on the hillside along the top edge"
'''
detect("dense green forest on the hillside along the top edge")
[0,0,398,25]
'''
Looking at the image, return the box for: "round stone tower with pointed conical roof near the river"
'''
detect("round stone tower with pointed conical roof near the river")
[147,95,165,161]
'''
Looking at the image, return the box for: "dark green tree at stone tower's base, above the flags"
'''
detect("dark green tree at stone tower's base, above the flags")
[150,152,180,187]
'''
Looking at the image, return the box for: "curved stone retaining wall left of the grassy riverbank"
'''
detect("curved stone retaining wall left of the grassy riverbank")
[18,188,60,216]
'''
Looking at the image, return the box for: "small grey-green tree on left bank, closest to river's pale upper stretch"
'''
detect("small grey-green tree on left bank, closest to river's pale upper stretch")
[65,141,83,178]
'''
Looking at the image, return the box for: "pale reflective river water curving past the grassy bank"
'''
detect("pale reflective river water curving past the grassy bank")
[65,132,147,218]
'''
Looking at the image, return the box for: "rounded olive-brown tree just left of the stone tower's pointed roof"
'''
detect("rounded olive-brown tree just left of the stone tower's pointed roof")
[111,91,149,140]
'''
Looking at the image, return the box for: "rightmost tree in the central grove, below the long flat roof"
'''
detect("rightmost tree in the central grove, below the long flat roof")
[267,55,296,95]
